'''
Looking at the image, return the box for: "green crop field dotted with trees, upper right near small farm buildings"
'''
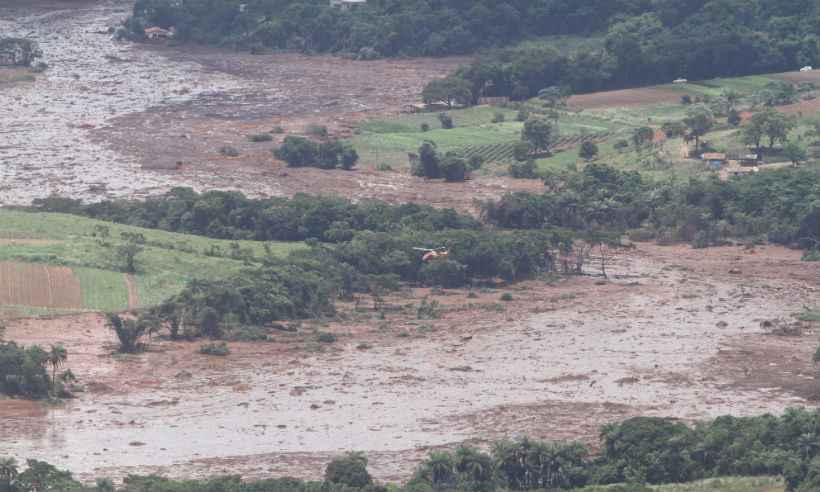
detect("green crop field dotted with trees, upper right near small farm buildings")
[351,69,814,178]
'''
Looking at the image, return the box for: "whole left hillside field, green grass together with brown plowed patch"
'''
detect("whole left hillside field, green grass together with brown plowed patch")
[0,209,301,317]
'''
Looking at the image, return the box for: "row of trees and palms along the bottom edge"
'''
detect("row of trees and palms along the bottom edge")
[8,409,820,492]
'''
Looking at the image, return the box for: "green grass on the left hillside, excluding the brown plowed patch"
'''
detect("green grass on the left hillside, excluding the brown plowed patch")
[0,209,303,314]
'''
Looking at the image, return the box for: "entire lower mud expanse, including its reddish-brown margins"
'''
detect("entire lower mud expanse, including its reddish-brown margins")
[0,244,820,480]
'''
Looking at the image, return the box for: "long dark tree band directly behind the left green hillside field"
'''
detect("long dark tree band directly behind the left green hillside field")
[32,188,481,242]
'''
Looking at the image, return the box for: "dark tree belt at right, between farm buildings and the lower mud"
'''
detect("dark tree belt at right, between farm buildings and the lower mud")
[482,163,820,249]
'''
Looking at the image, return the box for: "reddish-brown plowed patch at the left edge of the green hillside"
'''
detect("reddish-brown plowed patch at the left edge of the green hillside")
[0,262,83,309]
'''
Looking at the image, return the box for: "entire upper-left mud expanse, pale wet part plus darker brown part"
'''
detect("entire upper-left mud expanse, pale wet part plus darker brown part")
[0,0,540,210]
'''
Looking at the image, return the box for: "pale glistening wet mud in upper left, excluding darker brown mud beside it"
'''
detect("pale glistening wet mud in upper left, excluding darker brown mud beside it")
[0,0,239,205]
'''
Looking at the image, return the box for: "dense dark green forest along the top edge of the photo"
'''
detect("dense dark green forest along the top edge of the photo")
[126,0,820,98]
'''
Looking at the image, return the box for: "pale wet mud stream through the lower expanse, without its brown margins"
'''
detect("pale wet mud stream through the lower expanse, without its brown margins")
[0,252,807,482]
